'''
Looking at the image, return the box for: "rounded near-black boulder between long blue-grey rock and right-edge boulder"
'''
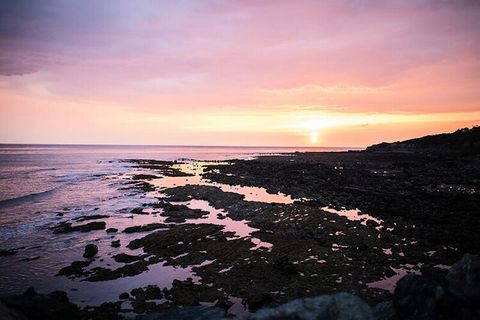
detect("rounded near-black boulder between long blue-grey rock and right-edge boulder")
[393,274,459,320]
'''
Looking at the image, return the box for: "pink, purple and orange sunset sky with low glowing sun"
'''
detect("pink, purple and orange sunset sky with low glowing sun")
[0,0,480,147]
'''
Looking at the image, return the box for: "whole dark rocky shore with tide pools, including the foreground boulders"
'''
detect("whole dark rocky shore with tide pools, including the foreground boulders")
[2,144,480,319]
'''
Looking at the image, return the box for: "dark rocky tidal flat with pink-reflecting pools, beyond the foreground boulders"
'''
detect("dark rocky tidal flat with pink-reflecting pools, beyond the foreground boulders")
[0,146,480,315]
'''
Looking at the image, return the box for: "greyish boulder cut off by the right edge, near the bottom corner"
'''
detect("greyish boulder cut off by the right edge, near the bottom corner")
[446,253,480,300]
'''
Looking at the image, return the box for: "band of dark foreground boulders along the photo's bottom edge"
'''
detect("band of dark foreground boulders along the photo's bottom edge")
[0,254,480,320]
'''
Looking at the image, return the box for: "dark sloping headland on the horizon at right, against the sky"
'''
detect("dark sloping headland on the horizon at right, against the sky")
[367,126,480,154]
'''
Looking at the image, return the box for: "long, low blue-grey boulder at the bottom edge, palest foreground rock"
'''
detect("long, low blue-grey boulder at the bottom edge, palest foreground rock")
[240,292,375,320]
